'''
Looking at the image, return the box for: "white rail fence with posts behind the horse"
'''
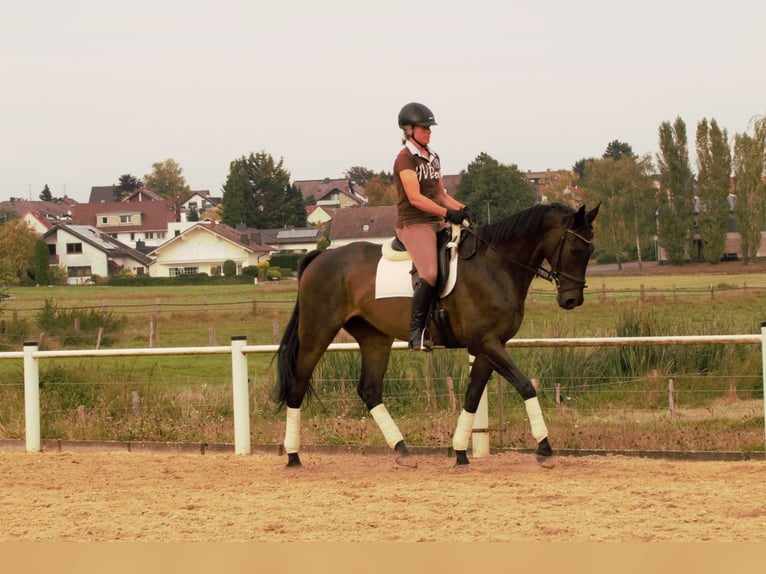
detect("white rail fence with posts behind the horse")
[0,321,766,454]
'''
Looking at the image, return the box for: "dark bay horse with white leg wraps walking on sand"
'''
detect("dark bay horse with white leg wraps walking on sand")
[275,205,599,466]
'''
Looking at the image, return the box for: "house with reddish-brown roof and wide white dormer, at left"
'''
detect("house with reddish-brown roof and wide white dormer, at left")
[72,199,176,250]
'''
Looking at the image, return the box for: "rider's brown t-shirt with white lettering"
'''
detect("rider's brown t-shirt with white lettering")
[394,144,442,227]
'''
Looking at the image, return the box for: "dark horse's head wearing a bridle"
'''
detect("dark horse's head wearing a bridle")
[545,203,601,310]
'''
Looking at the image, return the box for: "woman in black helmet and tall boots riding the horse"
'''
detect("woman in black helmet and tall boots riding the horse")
[394,102,471,351]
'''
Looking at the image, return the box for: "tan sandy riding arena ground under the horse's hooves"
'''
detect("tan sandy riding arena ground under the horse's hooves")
[0,452,766,542]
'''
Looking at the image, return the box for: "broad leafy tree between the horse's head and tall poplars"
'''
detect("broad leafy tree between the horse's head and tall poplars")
[585,154,654,269]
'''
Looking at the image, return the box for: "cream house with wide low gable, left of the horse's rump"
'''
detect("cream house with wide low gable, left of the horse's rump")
[149,221,271,277]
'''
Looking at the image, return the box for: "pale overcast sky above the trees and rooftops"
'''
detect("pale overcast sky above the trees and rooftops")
[0,0,766,201]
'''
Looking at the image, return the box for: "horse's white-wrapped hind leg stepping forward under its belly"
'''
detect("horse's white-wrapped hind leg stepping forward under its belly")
[344,317,417,466]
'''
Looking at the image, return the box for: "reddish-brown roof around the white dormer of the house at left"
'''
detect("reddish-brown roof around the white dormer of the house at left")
[72,201,176,233]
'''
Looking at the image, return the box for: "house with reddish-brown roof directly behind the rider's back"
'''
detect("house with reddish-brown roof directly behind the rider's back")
[330,205,397,249]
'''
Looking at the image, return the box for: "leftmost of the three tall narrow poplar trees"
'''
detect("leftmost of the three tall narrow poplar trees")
[657,117,694,265]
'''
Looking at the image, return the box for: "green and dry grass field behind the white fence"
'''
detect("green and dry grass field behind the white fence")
[0,263,766,450]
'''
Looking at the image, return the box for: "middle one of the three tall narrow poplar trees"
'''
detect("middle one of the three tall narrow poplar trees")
[696,119,731,263]
